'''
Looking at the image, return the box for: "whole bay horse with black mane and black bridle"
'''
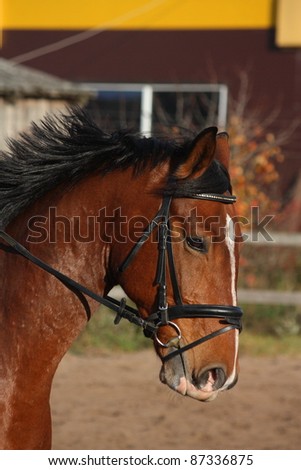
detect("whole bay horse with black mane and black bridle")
[0,108,242,449]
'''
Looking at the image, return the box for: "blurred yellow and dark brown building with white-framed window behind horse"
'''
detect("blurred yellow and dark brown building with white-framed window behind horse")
[0,0,301,230]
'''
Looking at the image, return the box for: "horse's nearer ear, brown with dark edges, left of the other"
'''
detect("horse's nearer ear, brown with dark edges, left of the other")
[175,127,217,179]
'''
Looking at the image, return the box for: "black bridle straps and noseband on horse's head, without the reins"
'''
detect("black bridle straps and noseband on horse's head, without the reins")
[119,193,243,362]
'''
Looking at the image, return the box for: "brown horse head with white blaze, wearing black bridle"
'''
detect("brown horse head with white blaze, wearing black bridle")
[112,128,242,401]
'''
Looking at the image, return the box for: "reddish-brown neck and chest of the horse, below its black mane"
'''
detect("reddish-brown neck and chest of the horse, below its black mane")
[0,164,169,448]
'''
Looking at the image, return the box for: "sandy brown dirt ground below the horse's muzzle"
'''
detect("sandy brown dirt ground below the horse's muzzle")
[51,350,301,450]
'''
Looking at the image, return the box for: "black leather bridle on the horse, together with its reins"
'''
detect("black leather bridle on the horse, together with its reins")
[0,193,243,362]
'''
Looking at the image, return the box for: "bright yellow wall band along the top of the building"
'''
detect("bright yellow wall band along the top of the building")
[0,0,273,29]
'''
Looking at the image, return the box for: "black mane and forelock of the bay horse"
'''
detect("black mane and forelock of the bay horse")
[0,108,229,228]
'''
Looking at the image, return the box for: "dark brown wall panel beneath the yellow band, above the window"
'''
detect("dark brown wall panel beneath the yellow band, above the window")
[0,30,301,188]
